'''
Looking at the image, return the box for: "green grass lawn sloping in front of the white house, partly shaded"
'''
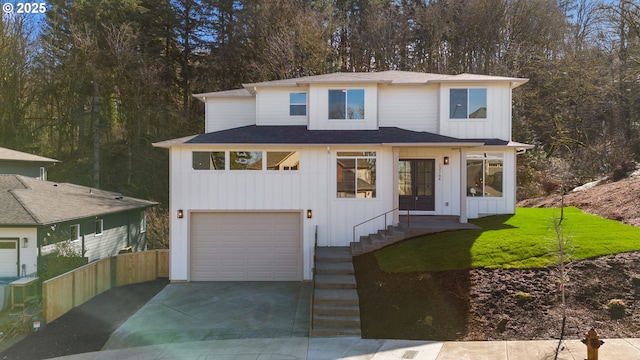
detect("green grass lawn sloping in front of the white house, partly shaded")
[375,207,640,272]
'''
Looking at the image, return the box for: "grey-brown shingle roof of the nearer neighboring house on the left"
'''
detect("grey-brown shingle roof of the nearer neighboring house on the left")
[0,175,157,225]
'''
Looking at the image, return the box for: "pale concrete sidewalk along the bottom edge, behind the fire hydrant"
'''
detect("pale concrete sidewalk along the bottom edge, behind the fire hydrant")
[47,337,640,360]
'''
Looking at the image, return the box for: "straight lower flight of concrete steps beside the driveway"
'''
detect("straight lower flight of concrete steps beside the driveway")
[309,247,361,337]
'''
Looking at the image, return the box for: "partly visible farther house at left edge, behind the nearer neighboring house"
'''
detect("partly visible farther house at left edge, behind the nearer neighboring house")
[0,147,60,180]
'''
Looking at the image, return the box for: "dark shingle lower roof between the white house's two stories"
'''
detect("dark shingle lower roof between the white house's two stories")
[184,125,478,145]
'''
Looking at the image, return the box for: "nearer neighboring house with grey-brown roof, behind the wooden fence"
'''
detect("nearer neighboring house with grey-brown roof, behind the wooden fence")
[0,174,157,277]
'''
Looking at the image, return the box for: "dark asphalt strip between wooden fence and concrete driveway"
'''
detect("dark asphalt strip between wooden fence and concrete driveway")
[0,279,169,360]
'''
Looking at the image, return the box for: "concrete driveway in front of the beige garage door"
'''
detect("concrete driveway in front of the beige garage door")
[103,282,311,350]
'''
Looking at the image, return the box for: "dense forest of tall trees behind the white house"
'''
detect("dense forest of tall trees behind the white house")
[0,0,640,204]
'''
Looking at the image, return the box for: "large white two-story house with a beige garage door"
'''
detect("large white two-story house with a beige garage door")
[154,71,531,281]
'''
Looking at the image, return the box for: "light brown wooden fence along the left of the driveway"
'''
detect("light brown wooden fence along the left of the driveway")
[42,250,169,323]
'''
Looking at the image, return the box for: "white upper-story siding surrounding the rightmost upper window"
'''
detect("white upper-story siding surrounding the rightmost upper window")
[440,83,511,141]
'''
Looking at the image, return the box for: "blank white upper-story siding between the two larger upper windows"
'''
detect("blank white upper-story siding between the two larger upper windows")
[378,85,439,133]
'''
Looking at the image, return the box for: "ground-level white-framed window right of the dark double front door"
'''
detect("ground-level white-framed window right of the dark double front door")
[467,153,504,197]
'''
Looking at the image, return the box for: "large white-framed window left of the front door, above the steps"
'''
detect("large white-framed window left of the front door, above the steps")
[336,151,376,198]
